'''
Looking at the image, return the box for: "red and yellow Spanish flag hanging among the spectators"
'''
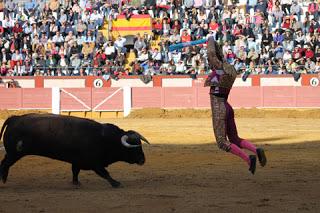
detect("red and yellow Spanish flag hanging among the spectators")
[111,15,152,39]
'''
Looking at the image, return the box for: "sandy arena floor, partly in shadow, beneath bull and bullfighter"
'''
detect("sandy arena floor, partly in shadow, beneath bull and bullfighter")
[0,110,320,213]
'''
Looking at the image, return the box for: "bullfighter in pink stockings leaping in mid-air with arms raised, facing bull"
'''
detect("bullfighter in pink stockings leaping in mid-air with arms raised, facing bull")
[205,38,267,174]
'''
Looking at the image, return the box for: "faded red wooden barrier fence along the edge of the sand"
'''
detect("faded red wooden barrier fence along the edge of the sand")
[0,86,320,111]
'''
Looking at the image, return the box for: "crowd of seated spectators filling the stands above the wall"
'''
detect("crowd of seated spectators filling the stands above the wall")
[0,0,320,78]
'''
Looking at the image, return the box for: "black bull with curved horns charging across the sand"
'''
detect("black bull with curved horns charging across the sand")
[0,114,148,187]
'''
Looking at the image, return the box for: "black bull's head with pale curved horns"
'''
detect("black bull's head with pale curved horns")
[121,130,150,165]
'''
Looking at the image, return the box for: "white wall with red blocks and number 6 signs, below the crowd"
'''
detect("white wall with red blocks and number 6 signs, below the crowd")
[0,75,318,88]
